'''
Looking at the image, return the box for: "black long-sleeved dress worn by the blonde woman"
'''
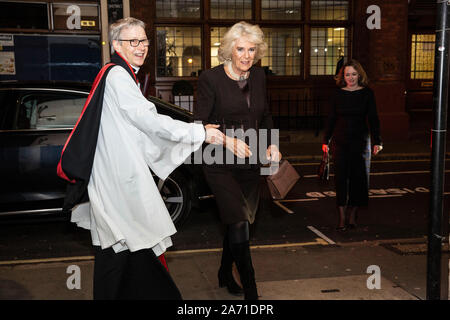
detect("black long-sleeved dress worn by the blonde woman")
[194,65,273,224]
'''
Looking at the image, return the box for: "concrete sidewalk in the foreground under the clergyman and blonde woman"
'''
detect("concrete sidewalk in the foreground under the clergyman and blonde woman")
[0,239,449,300]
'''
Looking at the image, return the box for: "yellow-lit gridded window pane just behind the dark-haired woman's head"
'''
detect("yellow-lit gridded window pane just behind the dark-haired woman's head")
[310,28,348,75]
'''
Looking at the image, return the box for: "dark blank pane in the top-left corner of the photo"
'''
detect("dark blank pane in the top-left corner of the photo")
[0,2,48,29]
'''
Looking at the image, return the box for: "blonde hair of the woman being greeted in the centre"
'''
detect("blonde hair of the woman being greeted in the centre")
[218,21,267,64]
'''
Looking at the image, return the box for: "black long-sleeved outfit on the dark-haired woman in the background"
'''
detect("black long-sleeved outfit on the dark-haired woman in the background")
[323,88,382,206]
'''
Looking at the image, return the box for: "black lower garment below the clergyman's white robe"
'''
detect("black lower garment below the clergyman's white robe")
[94,246,182,300]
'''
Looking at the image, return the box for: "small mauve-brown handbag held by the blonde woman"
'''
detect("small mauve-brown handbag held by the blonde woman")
[267,160,300,200]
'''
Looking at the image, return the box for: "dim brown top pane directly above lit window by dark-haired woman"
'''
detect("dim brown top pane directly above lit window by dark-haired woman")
[311,0,348,20]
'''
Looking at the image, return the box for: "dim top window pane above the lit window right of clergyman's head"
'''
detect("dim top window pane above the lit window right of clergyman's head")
[156,0,201,18]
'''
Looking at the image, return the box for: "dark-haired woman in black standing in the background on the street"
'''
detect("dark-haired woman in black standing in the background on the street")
[322,60,383,231]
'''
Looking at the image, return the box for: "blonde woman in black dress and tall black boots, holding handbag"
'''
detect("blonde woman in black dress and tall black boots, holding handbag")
[194,22,281,300]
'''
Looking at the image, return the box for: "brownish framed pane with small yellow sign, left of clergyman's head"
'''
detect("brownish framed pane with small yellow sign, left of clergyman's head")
[52,3,99,31]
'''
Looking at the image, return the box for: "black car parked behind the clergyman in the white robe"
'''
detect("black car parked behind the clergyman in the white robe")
[0,82,208,226]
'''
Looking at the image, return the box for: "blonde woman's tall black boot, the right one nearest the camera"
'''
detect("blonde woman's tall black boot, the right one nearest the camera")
[231,241,258,300]
